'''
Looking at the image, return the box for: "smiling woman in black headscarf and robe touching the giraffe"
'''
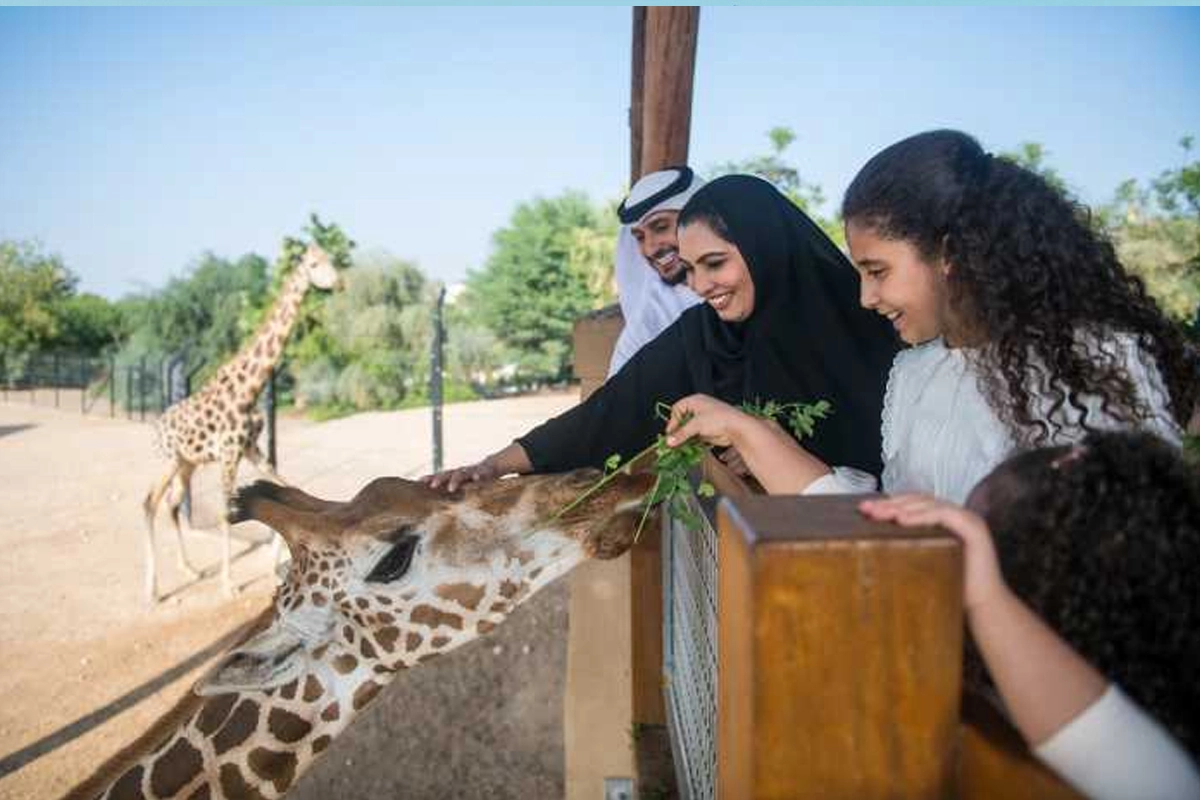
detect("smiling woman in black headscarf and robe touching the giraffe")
[427,175,898,491]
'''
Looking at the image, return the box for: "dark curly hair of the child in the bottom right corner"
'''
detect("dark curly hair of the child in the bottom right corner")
[967,432,1200,756]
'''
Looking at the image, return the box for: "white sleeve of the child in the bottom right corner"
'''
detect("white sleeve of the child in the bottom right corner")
[1033,685,1200,800]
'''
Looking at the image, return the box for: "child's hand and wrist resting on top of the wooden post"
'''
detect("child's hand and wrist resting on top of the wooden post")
[858,494,1008,610]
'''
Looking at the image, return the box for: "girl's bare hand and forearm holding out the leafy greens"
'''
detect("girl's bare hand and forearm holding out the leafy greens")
[667,395,830,494]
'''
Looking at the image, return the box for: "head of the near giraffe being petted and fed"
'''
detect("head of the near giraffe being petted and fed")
[197,470,653,695]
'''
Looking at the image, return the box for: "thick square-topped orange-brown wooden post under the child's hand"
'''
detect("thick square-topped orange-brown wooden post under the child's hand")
[716,497,962,800]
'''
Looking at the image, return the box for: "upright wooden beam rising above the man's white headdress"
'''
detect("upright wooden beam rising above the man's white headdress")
[641,6,700,175]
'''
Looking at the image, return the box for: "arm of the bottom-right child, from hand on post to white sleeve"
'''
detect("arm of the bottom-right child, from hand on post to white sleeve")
[859,494,1200,799]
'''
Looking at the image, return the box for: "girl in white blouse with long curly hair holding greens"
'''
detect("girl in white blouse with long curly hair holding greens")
[668,131,1198,503]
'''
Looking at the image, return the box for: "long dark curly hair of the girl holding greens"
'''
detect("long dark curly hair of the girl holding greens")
[842,131,1198,445]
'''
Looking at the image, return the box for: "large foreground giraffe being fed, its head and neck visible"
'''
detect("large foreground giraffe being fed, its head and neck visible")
[66,469,653,800]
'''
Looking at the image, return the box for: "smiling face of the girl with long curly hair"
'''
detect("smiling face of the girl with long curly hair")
[846,221,949,344]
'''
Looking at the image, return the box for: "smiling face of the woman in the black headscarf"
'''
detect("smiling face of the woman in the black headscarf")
[679,219,754,323]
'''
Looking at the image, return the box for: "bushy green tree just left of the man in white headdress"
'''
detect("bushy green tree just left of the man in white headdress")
[468,192,602,380]
